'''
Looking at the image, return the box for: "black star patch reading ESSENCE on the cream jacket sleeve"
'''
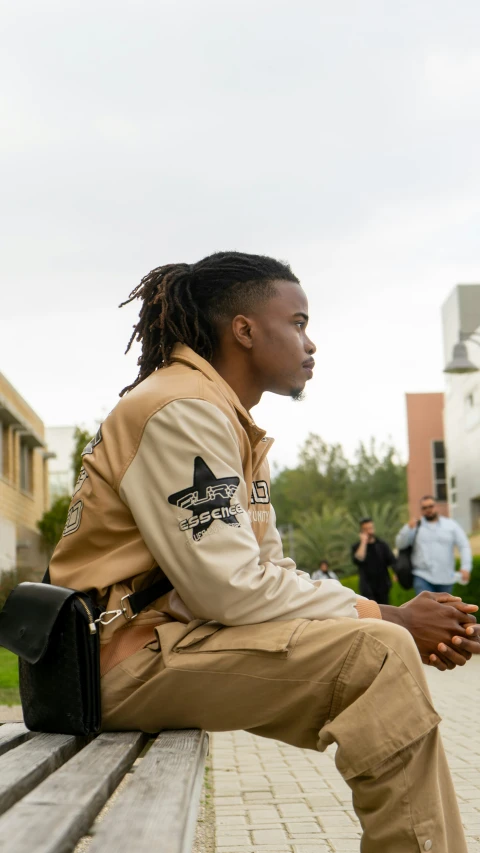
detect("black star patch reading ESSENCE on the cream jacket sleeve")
[168,456,243,542]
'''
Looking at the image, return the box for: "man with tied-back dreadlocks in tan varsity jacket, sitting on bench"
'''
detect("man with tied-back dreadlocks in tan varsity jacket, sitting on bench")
[50,252,480,853]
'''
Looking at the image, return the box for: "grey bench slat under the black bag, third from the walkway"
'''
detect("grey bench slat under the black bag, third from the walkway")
[0,734,85,814]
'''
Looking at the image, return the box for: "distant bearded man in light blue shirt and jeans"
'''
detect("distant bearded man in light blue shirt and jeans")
[396,495,472,595]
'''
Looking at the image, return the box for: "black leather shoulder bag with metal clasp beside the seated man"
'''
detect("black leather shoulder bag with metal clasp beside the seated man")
[0,570,173,735]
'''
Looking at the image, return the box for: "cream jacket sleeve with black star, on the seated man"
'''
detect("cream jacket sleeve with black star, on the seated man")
[119,399,358,625]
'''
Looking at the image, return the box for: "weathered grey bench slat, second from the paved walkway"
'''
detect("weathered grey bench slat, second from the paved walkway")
[0,732,148,853]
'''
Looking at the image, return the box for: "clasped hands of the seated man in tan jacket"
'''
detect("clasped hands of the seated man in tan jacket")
[380,592,480,671]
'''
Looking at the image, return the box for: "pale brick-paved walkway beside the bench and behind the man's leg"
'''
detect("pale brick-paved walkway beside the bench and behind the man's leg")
[212,659,480,853]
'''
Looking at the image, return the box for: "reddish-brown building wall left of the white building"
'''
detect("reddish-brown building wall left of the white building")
[406,393,449,518]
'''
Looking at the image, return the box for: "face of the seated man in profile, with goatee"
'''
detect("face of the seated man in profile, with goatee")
[251,281,316,399]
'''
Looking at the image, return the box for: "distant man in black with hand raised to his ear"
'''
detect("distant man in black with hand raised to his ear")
[352,518,395,604]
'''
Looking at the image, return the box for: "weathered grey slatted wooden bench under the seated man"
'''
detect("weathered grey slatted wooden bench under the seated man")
[0,723,208,853]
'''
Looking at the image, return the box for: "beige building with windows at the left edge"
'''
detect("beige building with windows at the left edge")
[0,373,48,572]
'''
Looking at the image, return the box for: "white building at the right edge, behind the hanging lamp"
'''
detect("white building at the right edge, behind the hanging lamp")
[442,284,480,533]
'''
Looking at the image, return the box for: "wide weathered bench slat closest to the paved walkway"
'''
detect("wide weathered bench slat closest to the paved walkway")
[88,729,208,853]
